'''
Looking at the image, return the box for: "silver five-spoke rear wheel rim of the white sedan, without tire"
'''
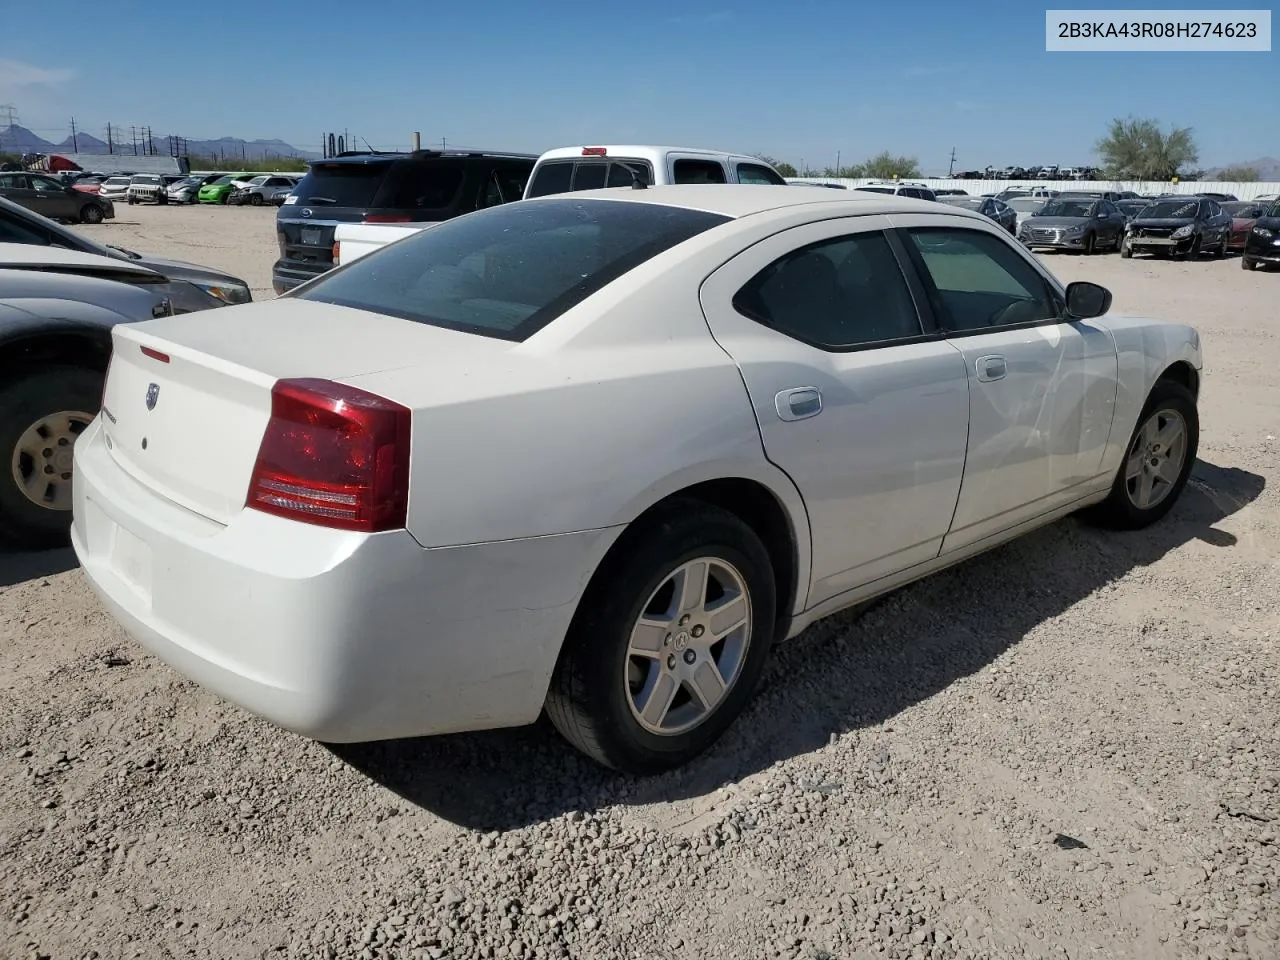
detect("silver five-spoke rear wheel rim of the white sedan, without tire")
[623,557,751,736]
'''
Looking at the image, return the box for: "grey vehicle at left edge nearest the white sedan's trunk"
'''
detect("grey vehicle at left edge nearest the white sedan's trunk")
[0,264,172,547]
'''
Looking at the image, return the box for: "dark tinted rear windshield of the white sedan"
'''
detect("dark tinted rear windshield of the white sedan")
[287,200,730,340]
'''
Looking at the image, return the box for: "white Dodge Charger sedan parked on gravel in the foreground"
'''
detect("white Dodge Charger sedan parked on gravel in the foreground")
[73,184,1202,773]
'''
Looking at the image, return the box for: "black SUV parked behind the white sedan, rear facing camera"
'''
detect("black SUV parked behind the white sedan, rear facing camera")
[271,150,538,293]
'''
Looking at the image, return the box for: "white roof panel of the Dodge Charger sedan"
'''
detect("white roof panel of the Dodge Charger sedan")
[522,183,987,223]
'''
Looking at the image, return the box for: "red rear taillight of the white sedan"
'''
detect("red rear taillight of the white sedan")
[244,379,411,534]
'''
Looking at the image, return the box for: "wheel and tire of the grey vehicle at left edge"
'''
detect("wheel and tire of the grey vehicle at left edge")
[0,366,102,548]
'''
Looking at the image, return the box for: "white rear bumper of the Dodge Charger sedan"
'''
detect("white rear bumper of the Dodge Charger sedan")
[72,421,614,742]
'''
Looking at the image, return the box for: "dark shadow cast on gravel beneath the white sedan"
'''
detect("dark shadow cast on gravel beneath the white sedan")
[329,461,1266,831]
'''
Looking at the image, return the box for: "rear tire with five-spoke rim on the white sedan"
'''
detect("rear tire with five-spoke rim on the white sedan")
[547,500,776,774]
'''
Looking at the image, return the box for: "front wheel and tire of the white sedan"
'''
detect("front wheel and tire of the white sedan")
[1091,380,1199,530]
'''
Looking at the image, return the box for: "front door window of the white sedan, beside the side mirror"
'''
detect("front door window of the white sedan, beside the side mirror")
[908,227,1062,333]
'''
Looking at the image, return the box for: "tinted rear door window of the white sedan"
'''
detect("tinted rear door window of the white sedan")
[733,232,922,349]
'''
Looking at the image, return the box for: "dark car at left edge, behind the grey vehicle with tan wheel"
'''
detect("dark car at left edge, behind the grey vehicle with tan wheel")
[0,198,253,314]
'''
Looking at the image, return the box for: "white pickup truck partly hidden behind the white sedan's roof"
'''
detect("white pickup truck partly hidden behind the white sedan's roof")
[333,145,787,265]
